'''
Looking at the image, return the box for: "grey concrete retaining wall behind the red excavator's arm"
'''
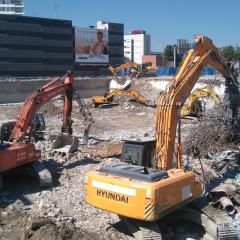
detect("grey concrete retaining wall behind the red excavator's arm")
[0,78,110,104]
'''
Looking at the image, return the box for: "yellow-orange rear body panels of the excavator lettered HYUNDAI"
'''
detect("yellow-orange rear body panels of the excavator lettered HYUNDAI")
[85,169,202,221]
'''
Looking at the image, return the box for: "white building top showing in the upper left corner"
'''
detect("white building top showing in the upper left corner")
[0,0,24,15]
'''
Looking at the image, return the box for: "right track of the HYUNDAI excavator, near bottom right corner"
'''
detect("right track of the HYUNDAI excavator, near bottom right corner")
[173,200,236,240]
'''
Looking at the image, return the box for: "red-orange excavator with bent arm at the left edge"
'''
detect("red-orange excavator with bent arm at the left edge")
[0,72,74,189]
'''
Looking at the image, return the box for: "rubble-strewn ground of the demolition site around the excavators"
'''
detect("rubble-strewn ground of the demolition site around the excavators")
[0,79,239,240]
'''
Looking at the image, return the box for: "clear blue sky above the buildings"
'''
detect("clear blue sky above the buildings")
[25,0,240,51]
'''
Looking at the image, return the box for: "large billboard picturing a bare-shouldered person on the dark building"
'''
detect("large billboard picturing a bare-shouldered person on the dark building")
[75,27,109,63]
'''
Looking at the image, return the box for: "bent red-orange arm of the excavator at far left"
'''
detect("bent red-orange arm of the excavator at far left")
[10,72,74,142]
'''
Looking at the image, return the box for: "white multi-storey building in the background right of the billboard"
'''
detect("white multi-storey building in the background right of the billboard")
[124,30,151,64]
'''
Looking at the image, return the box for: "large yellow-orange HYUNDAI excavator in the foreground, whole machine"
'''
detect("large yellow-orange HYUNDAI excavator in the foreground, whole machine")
[85,36,239,239]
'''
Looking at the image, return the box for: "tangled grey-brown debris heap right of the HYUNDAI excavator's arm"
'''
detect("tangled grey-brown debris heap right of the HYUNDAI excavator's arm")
[183,104,240,157]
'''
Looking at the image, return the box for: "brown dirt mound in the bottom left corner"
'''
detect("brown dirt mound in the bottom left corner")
[0,212,102,240]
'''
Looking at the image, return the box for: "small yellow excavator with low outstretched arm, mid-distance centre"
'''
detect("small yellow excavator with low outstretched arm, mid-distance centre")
[92,90,149,107]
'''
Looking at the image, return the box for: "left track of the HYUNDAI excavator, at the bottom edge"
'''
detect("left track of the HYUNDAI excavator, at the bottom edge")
[121,217,163,240]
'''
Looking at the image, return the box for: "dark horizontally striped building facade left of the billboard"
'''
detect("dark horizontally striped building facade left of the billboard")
[0,15,74,76]
